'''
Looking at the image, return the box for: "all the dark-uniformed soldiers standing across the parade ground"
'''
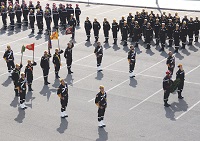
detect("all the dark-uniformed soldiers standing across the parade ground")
[1,1,200,127]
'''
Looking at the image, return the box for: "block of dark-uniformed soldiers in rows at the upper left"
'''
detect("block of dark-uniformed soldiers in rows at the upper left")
[0,0,81,34]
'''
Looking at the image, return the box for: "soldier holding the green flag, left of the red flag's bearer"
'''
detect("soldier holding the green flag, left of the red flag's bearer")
[12,64,22,96]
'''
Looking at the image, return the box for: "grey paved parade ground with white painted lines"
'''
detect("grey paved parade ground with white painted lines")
[0,1,200,141]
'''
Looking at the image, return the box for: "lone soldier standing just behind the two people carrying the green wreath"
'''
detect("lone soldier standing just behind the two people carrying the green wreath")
[166,51,175,76]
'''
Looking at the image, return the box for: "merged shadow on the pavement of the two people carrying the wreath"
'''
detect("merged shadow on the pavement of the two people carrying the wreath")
[164,99,188,121]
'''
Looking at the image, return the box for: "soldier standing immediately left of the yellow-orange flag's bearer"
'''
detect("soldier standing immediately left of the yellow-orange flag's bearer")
[40,51,51,85]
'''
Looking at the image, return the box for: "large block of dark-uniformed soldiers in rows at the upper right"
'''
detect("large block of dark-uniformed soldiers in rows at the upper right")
[85,10,200,53]
